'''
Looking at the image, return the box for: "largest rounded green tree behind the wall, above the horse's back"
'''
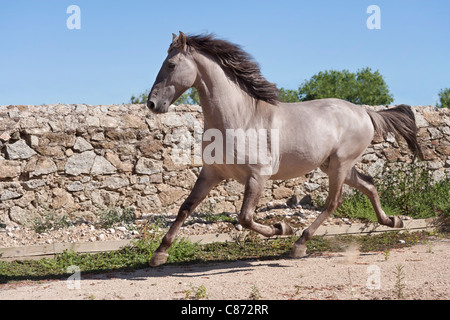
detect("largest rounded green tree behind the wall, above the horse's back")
[298,68,394,105]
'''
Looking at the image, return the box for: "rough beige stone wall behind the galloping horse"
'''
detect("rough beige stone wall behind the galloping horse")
[0,104,450,225]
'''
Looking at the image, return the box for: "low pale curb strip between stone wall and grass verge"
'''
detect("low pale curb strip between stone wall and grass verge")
[0,218,438,261]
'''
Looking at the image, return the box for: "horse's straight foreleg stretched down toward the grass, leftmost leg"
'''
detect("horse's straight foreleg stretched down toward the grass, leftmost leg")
[150,167,222,267]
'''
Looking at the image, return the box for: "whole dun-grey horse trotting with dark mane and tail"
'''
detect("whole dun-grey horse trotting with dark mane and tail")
[147,31,421,266]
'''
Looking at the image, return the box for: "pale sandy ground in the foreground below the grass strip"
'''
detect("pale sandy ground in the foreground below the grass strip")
[0,239,450,300]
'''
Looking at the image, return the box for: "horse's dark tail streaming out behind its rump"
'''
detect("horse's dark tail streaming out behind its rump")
[367,104,423,160]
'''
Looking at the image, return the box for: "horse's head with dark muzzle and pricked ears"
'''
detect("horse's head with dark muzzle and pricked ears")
[147,31,197,113]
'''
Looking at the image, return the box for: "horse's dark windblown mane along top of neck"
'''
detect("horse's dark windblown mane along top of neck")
[186,35,280,104]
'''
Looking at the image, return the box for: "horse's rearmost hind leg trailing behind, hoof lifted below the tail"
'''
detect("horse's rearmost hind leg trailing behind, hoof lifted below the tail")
[345,167,403,228]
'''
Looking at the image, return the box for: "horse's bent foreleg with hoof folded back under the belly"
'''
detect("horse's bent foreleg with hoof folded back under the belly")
[239,177,294,237]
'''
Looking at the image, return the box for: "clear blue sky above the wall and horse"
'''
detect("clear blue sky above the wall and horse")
[0,0,450,105]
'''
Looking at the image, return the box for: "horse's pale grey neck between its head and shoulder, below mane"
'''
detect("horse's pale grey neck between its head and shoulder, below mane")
[195,55,256,130]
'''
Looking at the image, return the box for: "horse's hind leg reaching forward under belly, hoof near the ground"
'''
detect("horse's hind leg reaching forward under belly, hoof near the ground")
[290,158,350,258]
